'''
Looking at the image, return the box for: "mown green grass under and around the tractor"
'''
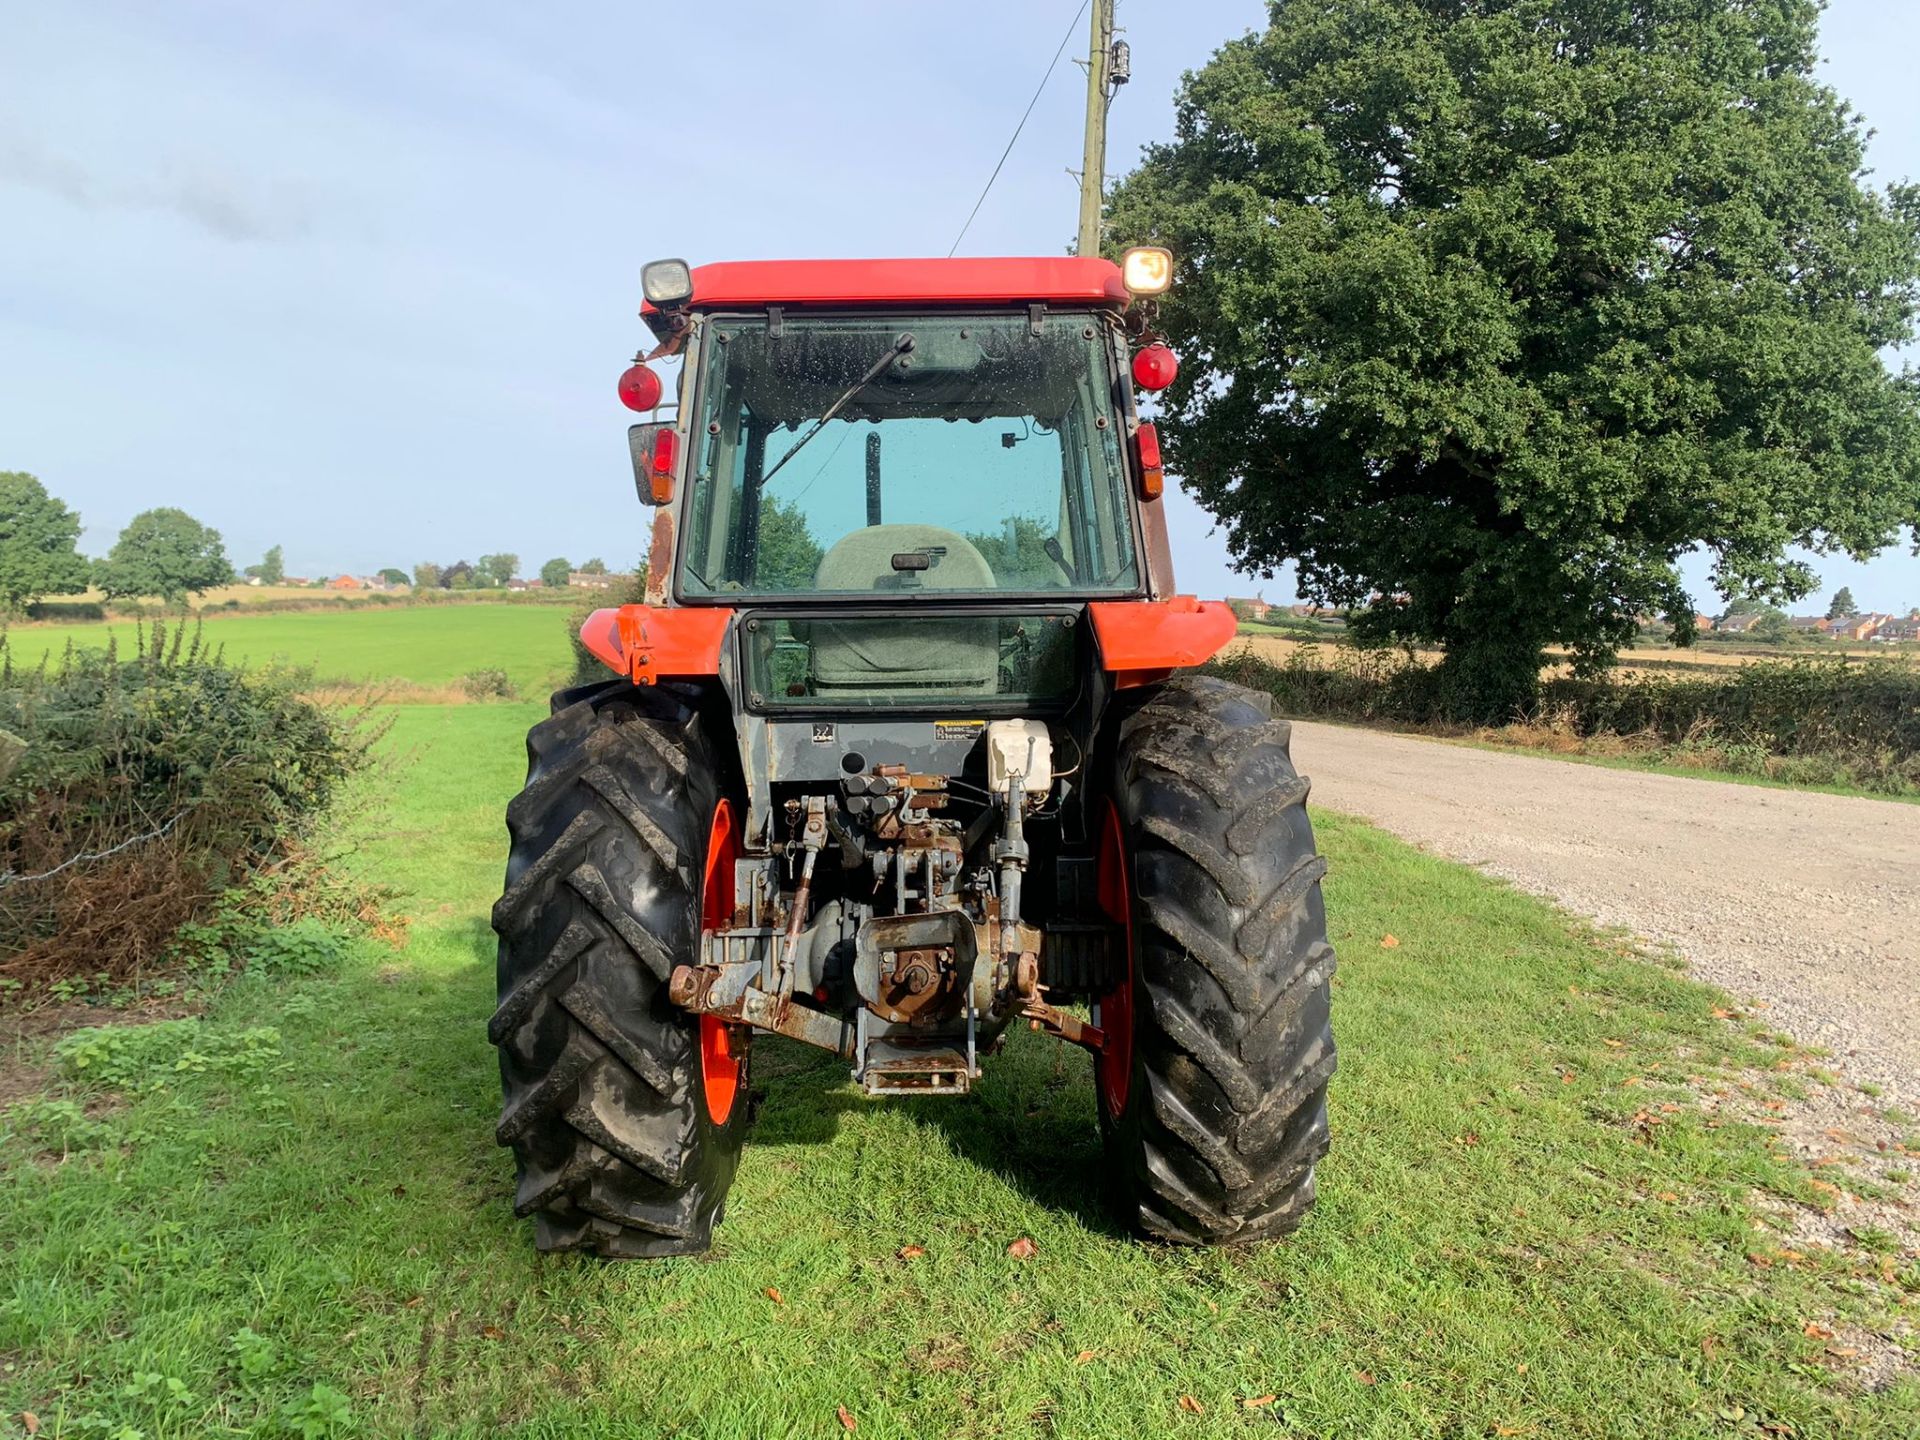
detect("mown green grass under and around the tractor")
[0,702,1920,1440]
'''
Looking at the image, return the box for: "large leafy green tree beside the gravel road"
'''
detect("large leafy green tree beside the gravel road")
[1110,0,1920,716]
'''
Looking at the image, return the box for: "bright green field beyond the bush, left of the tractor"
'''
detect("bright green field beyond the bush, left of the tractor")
[6,591,572,695]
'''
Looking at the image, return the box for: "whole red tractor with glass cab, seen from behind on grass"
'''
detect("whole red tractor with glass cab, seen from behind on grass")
[490,250,1334,1256]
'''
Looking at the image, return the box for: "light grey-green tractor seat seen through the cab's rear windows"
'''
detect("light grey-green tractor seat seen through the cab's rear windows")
[808,524,1000,699]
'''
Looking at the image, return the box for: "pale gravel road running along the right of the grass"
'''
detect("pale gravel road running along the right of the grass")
[1294,722,1920,1108]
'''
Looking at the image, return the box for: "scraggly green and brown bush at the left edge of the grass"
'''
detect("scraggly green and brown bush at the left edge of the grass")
[0,626,372,979]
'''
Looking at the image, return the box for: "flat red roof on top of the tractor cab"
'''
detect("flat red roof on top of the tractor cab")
[641,255,1129,315]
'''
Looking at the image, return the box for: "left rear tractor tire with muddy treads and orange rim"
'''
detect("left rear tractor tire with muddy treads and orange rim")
[488,682,747,1258]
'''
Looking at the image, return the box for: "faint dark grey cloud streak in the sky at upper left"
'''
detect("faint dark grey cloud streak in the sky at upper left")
[0,134,307,242]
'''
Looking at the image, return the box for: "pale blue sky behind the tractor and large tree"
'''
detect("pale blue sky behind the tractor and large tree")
[0,0,1920,611]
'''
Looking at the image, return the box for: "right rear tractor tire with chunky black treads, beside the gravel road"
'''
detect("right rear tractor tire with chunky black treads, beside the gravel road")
[1096,676,1334,1244]
